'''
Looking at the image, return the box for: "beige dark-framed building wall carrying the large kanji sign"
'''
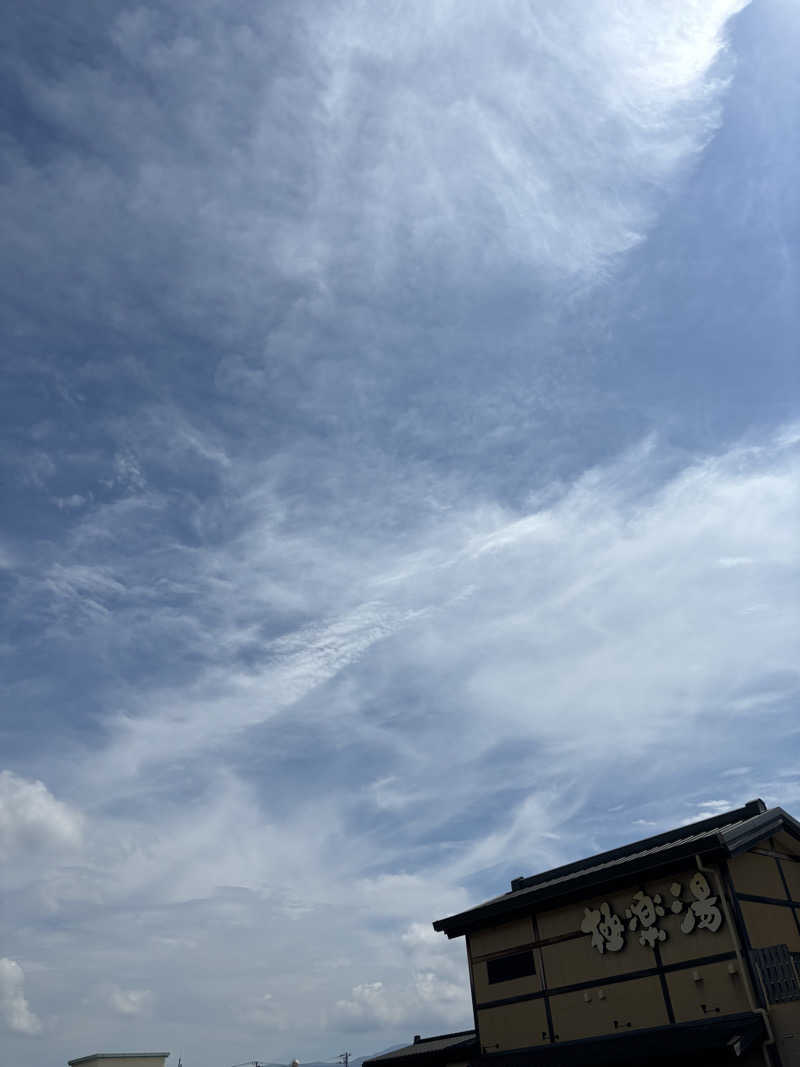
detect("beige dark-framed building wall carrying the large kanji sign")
[468,862,772,1054]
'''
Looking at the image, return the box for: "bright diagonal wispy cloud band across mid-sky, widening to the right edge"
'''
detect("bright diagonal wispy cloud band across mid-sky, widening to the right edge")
[40,424,797,809]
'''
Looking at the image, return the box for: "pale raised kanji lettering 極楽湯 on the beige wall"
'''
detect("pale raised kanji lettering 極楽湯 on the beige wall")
[580,871,722,955]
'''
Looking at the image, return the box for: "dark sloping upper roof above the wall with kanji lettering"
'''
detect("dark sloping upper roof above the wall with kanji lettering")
[433,800,800,937]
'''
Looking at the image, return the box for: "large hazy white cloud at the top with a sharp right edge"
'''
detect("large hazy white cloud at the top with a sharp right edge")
[0,0,746,392]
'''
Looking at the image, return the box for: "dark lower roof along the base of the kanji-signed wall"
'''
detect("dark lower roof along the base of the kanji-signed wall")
[480,1012,767,1067]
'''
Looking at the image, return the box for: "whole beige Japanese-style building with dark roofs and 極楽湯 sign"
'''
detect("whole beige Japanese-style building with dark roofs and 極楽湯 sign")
[364,800,800,1067]
